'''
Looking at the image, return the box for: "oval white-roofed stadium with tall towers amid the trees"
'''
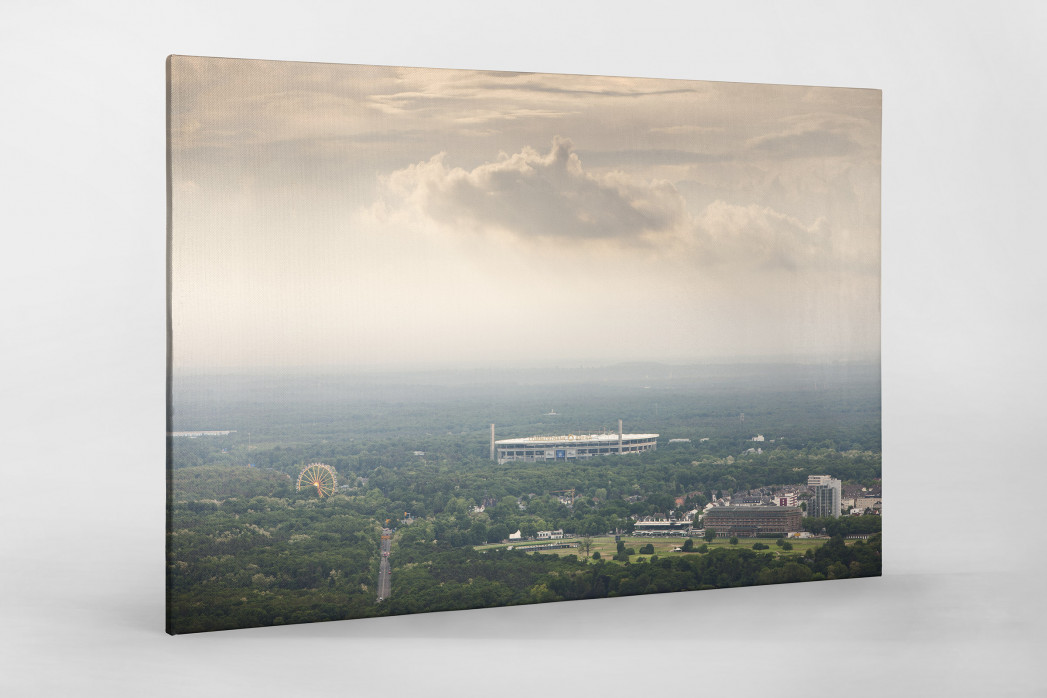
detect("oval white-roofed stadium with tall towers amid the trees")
[491,421,659,464]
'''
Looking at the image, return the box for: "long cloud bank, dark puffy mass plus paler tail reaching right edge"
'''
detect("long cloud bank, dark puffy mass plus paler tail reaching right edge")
[371,138,878,277]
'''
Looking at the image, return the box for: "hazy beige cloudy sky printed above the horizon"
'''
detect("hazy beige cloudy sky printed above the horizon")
[169,57,881,373]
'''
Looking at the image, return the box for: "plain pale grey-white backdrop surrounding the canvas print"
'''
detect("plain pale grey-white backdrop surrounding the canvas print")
[0,0,1047,696]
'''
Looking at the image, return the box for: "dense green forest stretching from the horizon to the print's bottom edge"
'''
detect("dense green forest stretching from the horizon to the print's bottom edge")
[168,365,882,633]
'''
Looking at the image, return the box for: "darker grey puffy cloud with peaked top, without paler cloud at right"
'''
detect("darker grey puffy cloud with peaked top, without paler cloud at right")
[384,138,688,246]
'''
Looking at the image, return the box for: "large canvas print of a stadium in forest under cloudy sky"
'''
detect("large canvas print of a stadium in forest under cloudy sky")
[166,57,883,633]
